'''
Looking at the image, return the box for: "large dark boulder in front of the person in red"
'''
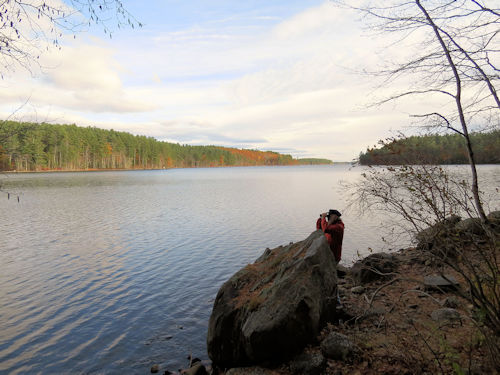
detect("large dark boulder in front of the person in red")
[207,231,337,368]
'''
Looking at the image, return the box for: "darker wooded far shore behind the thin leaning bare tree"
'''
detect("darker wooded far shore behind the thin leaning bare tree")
[359,130,500,165]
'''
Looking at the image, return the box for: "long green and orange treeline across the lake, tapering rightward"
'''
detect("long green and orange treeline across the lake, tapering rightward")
[0,121,332,171]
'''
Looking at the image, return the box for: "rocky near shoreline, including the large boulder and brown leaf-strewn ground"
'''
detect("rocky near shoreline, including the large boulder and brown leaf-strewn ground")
[151,212,500,375]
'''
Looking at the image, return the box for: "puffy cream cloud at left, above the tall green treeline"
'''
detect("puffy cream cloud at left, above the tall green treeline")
[0,43,155,113]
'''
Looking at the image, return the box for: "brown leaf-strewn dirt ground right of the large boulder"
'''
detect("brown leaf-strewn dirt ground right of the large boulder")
[292,249,497,375]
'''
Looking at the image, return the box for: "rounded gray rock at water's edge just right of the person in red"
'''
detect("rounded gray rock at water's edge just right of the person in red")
[350,253,398,284]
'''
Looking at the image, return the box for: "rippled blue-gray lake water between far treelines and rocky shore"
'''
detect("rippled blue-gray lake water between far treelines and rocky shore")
[0,165,500,374]
